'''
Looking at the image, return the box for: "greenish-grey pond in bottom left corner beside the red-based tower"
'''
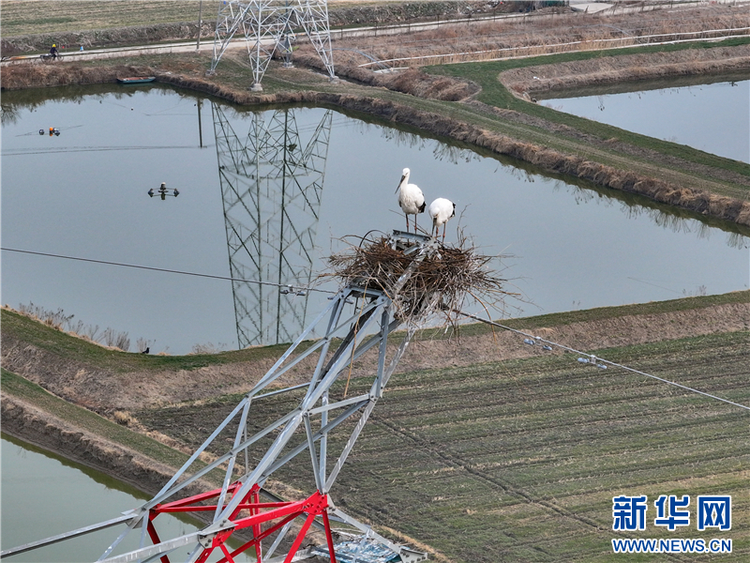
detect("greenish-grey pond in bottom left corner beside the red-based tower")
[0,434,254,563]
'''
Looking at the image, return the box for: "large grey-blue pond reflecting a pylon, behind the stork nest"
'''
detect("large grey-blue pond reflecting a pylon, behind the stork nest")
[2,86,750,354]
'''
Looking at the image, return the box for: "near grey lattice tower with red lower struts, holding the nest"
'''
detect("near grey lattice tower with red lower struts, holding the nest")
[0,231,439,563]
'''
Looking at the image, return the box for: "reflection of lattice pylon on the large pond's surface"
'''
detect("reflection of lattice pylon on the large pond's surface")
[212,104,333,348]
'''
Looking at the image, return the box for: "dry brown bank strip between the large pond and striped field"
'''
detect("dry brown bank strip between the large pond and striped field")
[2,303,750,416]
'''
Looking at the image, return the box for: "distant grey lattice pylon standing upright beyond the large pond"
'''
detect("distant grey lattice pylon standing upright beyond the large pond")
[209,0,336,90]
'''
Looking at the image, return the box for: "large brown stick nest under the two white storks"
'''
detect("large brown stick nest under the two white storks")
[328,236,509,324]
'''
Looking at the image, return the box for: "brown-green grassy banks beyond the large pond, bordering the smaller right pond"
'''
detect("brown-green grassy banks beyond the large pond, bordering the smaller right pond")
[3,39,750,227]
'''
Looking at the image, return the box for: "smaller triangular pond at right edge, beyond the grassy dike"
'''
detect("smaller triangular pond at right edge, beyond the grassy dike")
[542,77,750,162]
